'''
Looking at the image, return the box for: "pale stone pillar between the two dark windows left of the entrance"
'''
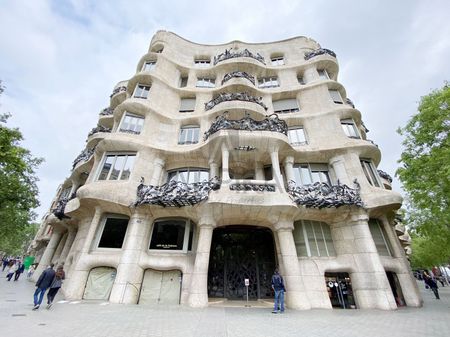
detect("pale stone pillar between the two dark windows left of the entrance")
[109,210,150,304]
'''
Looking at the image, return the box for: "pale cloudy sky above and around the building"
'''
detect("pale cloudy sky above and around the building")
[0,0,450,218]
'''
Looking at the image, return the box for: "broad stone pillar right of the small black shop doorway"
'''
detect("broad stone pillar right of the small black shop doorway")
[330,213,397,310]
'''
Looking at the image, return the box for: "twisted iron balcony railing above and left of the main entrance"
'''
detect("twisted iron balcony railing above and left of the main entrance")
[134,177,220,207]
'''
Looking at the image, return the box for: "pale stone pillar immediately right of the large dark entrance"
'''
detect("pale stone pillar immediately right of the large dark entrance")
[274,221,311,310]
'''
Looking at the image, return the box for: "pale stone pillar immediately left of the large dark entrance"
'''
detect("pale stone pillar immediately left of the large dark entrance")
[188,222,214,308]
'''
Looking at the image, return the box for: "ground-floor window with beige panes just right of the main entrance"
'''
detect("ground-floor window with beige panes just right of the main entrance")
[293,220,336,257]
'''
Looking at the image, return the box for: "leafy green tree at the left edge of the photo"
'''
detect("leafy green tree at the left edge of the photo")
[0,81,43,254]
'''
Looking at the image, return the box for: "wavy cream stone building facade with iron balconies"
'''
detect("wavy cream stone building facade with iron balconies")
[31,31,422,310]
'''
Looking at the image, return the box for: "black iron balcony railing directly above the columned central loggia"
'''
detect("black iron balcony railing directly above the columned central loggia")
[204,112,288,140]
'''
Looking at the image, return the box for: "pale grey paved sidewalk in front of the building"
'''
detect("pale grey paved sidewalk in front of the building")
[0,272,450,337]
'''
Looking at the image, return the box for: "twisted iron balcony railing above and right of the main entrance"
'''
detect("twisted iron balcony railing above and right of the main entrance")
[287,179,364,208]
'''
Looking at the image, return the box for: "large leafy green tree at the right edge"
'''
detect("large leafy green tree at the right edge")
[397,83,450,267]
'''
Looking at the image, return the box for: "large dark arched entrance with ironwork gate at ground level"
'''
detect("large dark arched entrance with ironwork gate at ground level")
[208,226,276,300]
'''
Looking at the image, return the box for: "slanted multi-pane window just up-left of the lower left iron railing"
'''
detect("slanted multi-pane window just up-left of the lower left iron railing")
[97,154,136,180]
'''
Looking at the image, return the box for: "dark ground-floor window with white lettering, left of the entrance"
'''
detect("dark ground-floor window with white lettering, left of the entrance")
[149,219,194,252]
